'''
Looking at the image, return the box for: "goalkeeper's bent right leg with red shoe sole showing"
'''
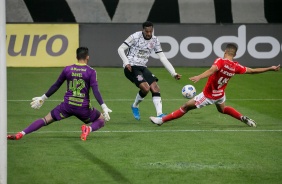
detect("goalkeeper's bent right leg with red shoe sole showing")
[80,108,105,141]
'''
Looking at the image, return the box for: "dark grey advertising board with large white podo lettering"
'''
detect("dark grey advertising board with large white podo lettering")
[80,24,282,67]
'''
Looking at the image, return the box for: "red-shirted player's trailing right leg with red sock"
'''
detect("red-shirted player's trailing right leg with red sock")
[215,96,256,127]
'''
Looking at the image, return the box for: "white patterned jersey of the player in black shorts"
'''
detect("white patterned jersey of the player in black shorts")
[123,31,162,67]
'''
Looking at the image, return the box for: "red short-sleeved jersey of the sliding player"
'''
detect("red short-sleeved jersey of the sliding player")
[203,58,247,100]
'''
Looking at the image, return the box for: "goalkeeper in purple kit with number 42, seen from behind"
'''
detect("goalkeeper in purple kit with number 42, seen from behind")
[7,47,112,141]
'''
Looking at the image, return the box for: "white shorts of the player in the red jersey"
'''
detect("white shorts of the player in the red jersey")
[194,92,226,108]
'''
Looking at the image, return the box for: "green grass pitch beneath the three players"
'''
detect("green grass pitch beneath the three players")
[7,68,282,184]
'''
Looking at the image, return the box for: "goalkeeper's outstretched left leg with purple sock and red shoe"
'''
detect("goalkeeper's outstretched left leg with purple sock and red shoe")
[7,113,54,140]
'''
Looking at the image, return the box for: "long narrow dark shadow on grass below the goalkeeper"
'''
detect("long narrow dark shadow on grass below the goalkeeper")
[74,144,130,183]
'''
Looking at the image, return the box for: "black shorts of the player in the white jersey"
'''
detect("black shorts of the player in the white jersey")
[124,66,159,87]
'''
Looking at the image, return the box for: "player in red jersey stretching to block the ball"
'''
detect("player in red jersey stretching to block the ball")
[150,44,280,127]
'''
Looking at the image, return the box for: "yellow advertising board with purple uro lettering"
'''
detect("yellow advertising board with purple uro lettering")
[6,24,79,67]
